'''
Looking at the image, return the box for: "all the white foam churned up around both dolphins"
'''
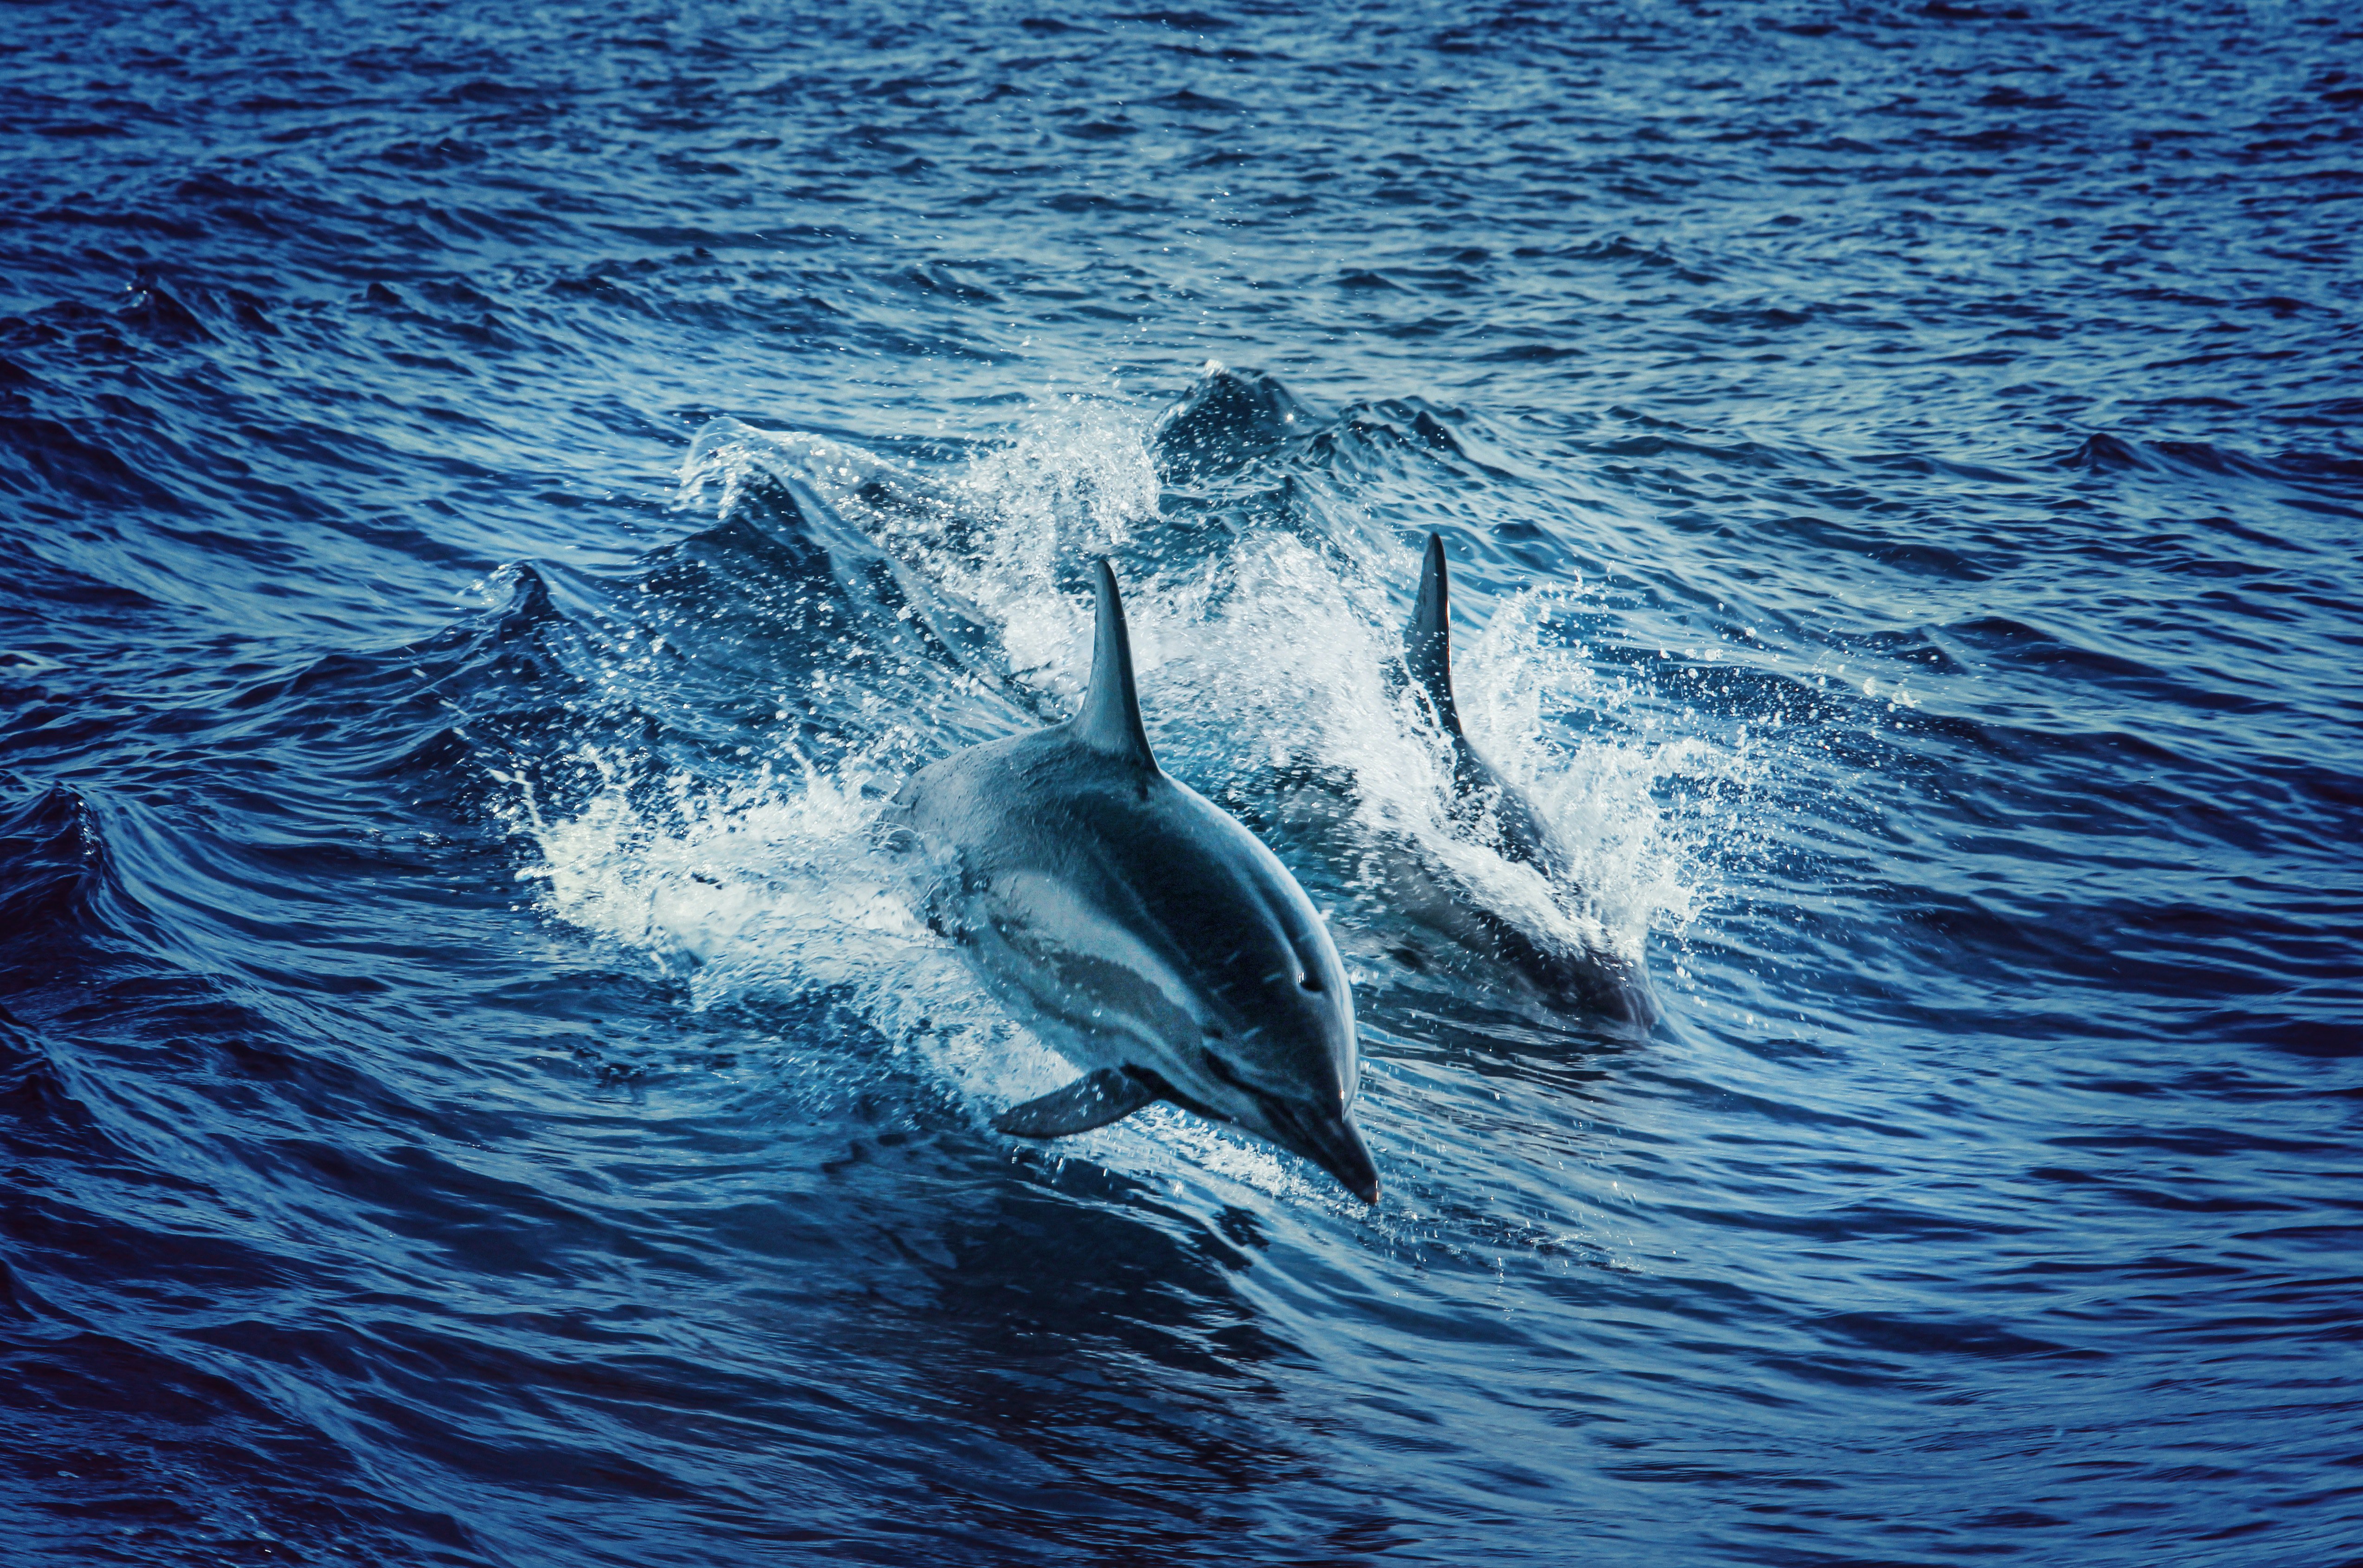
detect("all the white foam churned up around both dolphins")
[515,399,1753,1138]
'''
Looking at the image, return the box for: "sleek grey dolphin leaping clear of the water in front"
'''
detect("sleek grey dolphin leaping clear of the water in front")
[896,562,1378,1202]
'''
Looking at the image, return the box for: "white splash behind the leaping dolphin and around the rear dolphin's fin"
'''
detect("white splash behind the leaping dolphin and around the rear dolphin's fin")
[680,397,1753,992]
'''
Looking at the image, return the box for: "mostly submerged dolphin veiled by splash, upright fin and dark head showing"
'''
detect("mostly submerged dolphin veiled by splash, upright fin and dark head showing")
[1396,534,1656,1030]
